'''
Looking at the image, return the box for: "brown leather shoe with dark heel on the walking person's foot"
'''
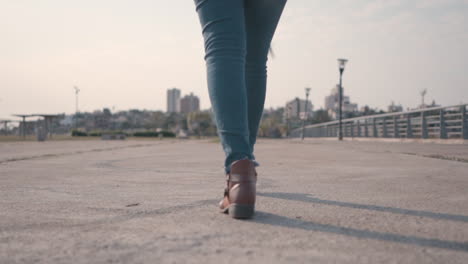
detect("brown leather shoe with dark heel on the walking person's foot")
[219,159,257,219]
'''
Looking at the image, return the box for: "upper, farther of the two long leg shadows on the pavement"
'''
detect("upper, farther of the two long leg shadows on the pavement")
[257,192,468,223]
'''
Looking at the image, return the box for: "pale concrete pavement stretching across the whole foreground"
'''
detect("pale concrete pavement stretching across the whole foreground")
[0,139,468,263]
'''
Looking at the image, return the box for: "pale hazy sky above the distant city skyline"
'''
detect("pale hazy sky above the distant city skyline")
[0,0,468,119]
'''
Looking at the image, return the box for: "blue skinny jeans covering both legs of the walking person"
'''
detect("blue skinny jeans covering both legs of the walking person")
[194,0,286,173]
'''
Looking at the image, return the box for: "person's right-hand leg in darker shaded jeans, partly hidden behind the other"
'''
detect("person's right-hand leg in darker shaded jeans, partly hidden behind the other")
[244,0,286,157]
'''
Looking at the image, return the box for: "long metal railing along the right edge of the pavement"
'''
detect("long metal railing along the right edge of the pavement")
[290,104,468,139]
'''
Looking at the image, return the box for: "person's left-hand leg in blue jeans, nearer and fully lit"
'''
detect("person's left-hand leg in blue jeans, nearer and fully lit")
[195,0,252,172]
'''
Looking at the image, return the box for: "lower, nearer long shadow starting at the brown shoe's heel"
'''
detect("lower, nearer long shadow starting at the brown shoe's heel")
[252,211,468,252]
